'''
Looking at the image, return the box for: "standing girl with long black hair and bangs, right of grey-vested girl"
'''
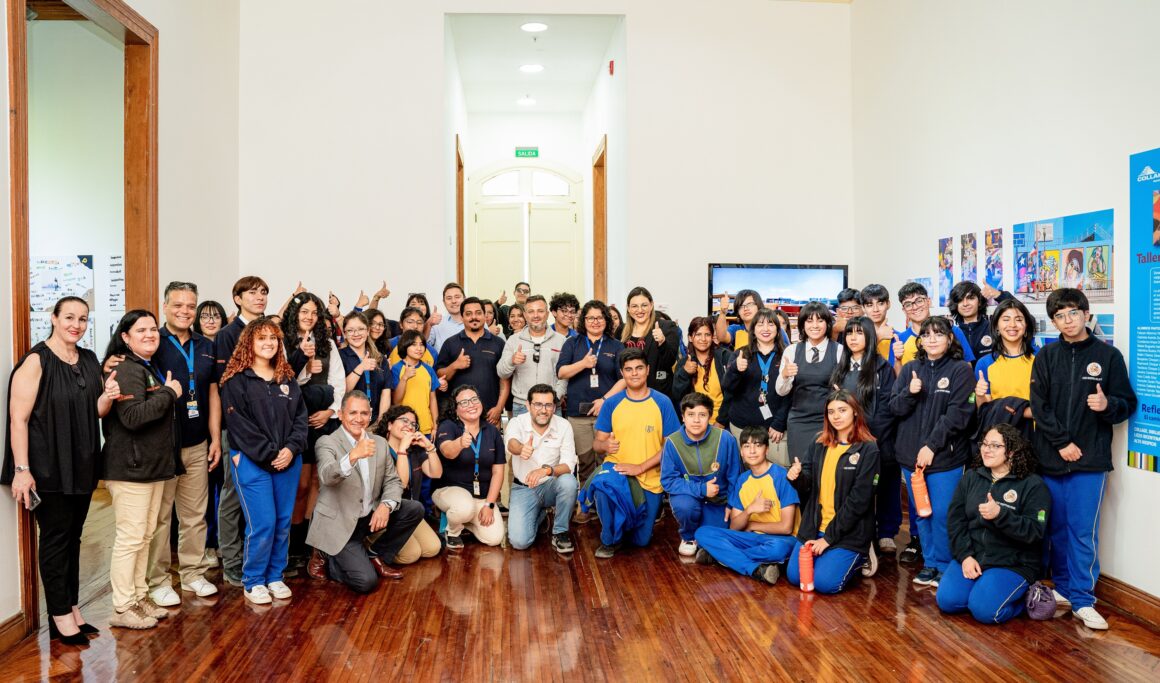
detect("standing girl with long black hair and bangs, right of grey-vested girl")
[831,315,902,554]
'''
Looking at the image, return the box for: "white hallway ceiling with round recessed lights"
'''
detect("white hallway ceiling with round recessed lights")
[449,14,621,112]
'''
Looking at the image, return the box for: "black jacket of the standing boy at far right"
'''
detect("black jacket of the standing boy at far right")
[1031,334,1136,474]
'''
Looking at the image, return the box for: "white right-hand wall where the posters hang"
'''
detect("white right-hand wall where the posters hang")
[851,0,1160,595]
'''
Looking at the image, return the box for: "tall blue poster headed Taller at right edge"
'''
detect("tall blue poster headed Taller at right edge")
[1128,150,1160,472]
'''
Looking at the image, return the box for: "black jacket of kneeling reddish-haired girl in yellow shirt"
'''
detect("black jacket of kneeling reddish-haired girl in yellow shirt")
[792,442,879,554]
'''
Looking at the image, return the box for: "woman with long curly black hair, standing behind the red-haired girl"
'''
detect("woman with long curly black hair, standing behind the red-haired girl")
[282,292,346,561]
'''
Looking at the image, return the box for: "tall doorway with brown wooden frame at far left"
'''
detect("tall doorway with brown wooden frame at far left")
[0,0,159,651]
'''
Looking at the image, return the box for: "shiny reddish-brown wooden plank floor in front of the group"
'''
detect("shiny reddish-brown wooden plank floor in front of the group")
[0,496,1160,683]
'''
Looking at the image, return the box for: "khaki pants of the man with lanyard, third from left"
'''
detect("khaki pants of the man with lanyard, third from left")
[148,441,209,590]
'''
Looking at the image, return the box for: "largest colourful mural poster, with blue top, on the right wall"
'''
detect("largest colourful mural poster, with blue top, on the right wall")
[1012,209,1115,304]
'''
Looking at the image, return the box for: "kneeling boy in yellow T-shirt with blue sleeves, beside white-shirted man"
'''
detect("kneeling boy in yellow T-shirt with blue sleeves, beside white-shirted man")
[581,347,681,559]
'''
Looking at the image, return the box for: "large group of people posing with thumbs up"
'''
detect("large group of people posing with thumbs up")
[0,276,1136,644]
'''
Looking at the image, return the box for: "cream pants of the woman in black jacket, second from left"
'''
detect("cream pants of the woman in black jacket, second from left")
[106,481,165,612]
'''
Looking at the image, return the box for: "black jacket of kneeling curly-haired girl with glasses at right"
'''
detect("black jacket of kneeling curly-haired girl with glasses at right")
[947,467,1051,583]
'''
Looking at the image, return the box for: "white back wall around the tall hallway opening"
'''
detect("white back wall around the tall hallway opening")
[240,0,854,320]
